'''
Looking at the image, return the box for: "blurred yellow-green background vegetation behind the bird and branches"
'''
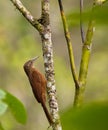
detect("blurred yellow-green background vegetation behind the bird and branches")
[0,0,108,130]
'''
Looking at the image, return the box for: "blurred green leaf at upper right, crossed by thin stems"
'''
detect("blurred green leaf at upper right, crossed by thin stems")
[67,2,108,27]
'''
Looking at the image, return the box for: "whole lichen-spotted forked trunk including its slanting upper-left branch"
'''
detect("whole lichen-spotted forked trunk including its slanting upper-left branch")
[10,0,62,130]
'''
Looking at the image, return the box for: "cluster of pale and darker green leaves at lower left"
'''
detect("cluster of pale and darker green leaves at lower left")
[0,89,27,129]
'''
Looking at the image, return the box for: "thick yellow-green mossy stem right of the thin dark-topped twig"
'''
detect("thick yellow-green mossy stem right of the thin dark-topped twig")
[74,3,95,107]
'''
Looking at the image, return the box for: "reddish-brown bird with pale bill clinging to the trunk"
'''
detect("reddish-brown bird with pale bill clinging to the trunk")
[23,56,53,125]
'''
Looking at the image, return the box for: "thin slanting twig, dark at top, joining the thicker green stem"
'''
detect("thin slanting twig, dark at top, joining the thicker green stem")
[58,0,79,87]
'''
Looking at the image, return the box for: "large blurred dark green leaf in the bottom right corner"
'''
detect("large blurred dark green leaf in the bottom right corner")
[61,102,108,130]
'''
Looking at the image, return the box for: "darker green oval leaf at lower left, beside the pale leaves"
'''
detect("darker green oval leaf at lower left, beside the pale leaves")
[3,93,27,124]
